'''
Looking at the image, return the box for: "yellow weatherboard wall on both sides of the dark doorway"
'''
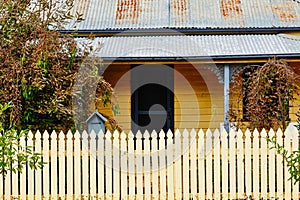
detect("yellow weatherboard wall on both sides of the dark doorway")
[100,64,223,132]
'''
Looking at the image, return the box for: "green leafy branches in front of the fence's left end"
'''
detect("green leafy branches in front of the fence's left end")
[0,104,45,177]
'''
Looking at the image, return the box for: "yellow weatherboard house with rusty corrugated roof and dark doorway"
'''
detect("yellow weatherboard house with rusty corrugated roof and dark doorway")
[60,0,300,131]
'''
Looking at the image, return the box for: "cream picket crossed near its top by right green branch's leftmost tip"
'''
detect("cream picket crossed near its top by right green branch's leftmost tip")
[268,129,276,199]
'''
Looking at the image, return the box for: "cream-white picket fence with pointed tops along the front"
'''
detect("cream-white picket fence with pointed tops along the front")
[0,129,300,200]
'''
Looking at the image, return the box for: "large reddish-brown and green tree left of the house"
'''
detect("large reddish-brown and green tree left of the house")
[0,0,118,131]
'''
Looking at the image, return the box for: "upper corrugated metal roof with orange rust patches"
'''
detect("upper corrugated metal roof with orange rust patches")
[66,0,300,30]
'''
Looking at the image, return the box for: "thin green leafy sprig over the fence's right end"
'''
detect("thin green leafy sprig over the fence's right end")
[267,137,300,184]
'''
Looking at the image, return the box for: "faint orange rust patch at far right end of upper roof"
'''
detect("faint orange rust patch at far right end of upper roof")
[272,3,296,22]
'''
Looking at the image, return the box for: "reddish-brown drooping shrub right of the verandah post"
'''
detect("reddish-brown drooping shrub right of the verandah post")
[228,59,298,130]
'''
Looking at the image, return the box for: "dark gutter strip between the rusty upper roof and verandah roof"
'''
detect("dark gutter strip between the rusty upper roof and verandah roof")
[58,27,300,37]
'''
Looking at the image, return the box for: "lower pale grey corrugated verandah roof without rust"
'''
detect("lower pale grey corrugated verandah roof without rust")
[77,34,300,59]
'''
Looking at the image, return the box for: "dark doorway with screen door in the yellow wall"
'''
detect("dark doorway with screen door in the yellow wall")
[131,65,174,133]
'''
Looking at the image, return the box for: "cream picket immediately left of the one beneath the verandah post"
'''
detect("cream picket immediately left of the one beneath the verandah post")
[213,129,221,199]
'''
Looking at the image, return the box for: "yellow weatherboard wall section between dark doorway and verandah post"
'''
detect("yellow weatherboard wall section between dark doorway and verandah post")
[174,64,223,130]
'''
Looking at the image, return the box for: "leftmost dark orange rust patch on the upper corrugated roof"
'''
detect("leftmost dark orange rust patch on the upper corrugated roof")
[116,0,141,24]
